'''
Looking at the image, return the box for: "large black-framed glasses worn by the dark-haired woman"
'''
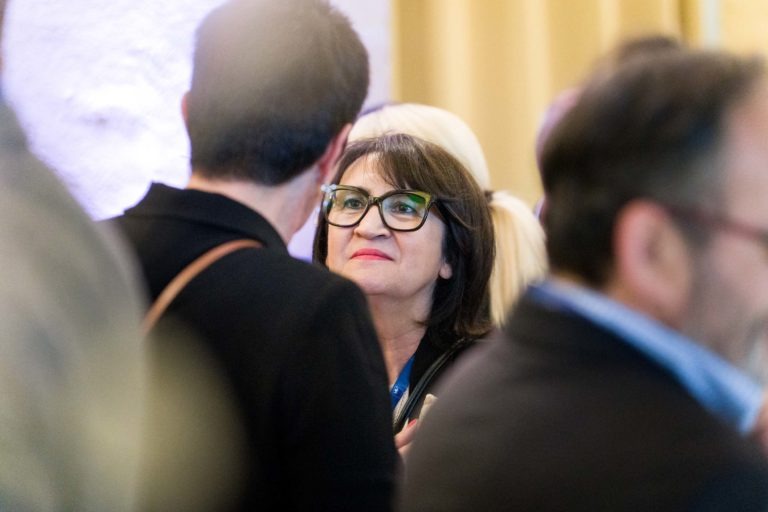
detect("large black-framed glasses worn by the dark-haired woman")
[322,185,435,231]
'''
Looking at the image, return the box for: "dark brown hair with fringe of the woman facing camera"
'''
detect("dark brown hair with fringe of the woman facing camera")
[314,134,494,339]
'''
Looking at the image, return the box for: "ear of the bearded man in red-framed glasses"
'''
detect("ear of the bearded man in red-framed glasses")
[611,200,692,325]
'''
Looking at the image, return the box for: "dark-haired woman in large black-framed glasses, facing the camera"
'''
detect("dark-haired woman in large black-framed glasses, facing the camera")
[314,134,494,452]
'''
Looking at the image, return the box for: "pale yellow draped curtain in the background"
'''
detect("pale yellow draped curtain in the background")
[392,0,768,204]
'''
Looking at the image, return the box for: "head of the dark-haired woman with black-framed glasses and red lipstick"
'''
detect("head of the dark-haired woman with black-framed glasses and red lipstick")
[315,134,494,338]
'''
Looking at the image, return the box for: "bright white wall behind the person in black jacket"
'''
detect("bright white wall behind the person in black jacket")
[4,0,390,218]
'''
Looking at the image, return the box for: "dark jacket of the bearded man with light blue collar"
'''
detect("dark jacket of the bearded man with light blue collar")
[402,290,768,512]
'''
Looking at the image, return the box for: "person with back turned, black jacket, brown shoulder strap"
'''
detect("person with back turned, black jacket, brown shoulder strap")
[109,0,397,511]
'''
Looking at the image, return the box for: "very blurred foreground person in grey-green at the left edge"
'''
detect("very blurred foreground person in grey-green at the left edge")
[0,0,145,512]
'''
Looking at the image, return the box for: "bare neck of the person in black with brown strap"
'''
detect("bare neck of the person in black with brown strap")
[186,171,318,244]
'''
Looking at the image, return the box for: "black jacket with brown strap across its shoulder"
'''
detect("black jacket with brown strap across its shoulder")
[112,184,396,510]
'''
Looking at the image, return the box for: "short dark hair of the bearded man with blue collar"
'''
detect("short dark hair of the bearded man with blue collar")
[542,49,764,288]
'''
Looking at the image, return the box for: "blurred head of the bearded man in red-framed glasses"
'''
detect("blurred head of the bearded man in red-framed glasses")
[542,50,768,372]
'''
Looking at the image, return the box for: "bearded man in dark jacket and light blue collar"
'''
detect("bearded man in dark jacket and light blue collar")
[404,46,768,512]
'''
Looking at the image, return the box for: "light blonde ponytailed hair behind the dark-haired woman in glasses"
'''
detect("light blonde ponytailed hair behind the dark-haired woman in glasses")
[349,103,546,326]
